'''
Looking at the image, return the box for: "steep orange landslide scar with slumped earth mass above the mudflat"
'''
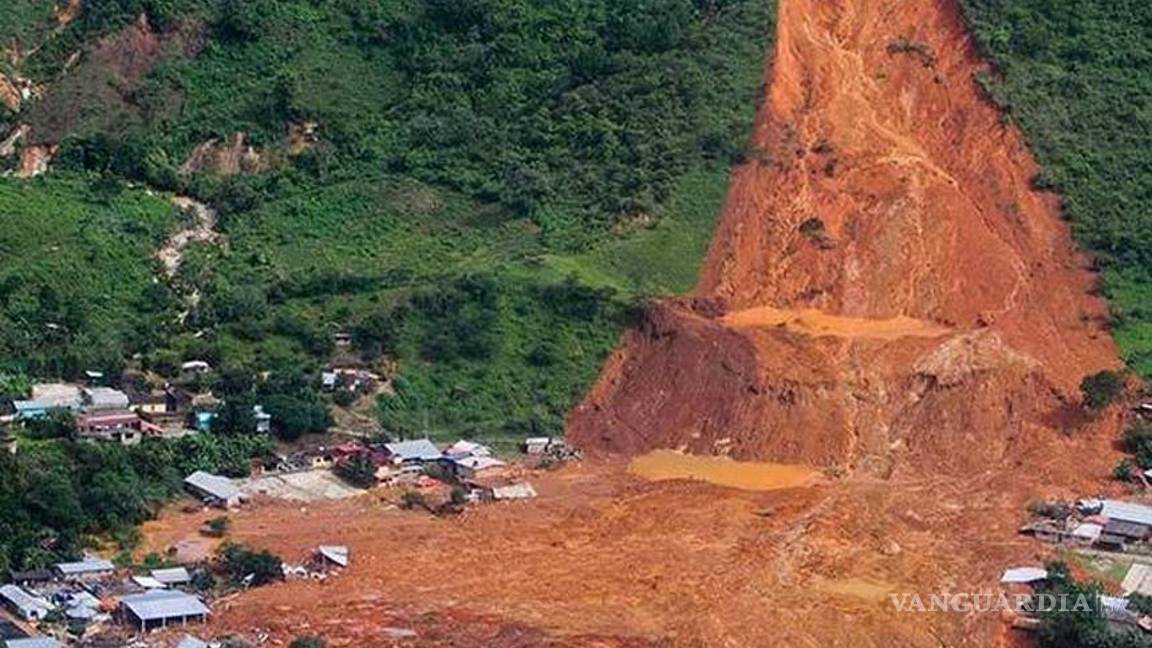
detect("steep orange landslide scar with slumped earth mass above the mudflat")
[569,0,1116,475]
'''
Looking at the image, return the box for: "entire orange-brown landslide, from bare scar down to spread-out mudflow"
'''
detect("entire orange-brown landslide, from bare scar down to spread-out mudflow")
[160,0,1121,648]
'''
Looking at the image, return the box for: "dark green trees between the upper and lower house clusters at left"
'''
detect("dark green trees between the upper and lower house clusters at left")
[0,435,271,573]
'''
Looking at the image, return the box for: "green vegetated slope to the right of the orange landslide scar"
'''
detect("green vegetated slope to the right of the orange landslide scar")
[962,0,1152,377]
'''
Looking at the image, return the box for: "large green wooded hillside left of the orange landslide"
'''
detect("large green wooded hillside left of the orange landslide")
[0,0,771,437]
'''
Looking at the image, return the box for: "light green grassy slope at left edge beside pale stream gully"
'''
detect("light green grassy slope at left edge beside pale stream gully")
[0,178,175,376]
